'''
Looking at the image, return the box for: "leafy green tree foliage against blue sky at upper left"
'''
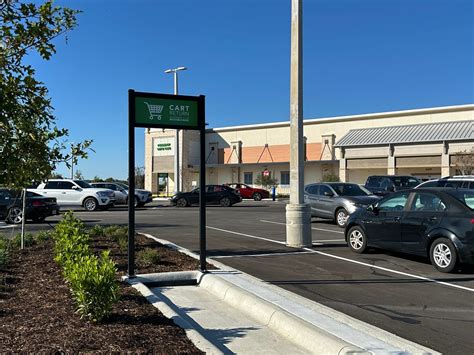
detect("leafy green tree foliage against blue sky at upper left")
[0,0,92,187]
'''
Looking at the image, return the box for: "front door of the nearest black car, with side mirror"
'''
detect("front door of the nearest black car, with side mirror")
[362,191,409,250]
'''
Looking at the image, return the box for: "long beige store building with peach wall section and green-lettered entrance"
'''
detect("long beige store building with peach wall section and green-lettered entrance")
[145,104,474,195]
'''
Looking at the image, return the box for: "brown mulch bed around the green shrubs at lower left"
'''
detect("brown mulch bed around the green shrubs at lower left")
[0,231,211,353]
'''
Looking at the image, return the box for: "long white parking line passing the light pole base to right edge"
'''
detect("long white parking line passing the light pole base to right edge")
[206,227,474,292]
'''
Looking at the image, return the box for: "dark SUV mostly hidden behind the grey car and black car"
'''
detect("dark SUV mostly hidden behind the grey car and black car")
[364,175,421,196]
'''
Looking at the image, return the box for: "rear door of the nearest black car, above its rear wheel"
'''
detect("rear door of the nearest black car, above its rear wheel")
[401,191,446,255]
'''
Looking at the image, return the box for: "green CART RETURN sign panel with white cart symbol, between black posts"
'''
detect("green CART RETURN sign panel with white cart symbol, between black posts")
[129,90,204,130]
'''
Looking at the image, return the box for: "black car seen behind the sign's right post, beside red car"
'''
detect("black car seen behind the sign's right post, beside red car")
[170,185,242,207]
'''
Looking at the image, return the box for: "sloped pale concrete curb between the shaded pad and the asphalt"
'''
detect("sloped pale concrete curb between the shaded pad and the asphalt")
[129,234,438,354]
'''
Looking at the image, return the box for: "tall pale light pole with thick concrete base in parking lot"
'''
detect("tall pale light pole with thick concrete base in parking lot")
[286,0,312,248]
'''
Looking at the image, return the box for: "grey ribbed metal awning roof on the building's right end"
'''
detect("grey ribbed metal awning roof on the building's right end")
[335,120,474,147]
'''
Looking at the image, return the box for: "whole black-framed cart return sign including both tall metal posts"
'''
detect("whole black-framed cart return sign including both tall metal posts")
[127,90,206,277]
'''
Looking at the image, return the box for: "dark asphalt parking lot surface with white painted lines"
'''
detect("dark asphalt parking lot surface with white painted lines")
[0,201,474,354]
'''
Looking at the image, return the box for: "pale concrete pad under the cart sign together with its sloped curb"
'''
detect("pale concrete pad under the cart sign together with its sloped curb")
[124,236,437,354]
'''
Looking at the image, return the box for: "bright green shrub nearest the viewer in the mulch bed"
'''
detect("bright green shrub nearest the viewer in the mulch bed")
[68,251,120,322]
